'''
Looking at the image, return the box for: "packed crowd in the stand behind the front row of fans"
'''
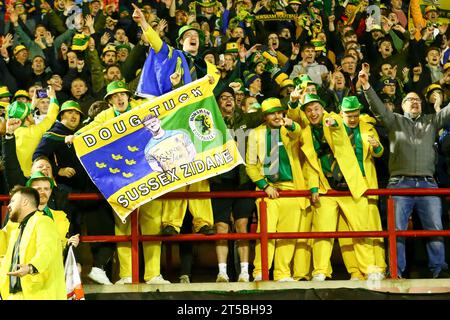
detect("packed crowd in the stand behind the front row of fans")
[0,0,450,284]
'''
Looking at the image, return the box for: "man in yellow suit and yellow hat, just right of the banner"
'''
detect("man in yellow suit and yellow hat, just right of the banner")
[246,98,307,282]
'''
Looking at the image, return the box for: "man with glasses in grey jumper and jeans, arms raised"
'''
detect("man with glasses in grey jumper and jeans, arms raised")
[359,63,450,278]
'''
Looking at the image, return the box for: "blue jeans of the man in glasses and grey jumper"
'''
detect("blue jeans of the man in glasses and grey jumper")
[387,176,448,276]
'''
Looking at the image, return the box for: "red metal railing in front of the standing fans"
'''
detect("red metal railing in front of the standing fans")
[0,188,450,283]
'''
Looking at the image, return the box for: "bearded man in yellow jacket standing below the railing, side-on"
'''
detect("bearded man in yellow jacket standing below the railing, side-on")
[0,186,67,300]
